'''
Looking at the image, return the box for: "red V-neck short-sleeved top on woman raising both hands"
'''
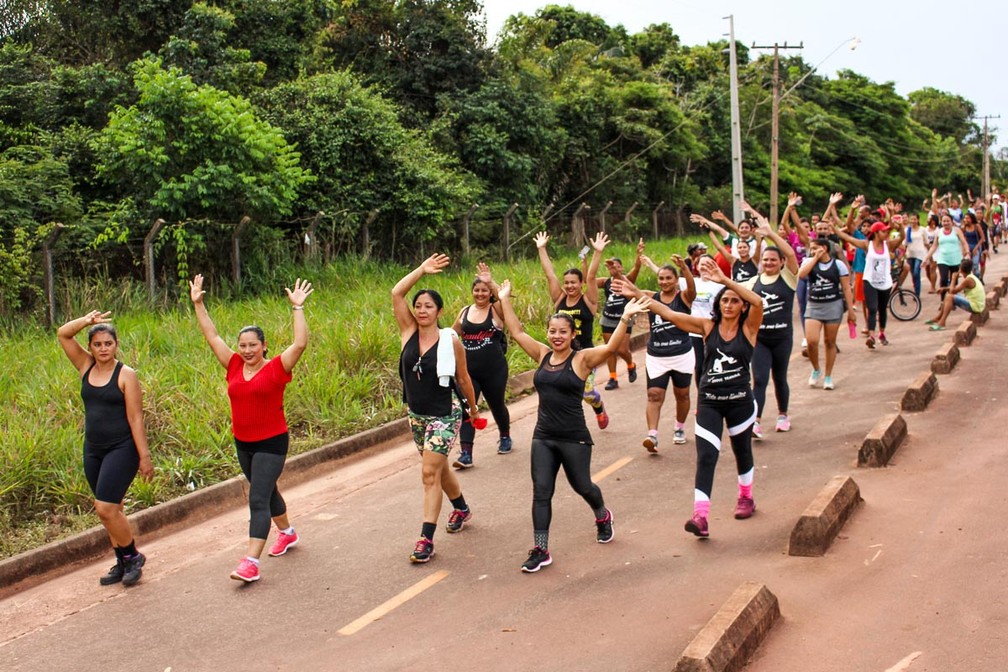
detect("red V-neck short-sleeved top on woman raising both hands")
[227,353,291,441]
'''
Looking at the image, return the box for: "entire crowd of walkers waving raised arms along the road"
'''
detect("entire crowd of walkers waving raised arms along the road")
[57,189,995,585]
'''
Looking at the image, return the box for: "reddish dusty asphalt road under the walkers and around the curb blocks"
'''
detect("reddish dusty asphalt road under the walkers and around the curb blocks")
[0,255,1008,672]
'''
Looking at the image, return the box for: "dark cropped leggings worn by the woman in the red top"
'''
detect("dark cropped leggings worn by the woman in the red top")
[235,432,290,539]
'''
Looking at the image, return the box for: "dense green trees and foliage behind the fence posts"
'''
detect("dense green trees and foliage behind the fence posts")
[0,0,1005,310]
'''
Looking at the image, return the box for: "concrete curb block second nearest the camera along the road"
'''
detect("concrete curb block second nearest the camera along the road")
[787,476,864,557]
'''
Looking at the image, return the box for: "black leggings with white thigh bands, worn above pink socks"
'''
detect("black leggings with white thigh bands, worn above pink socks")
[694,395,756,499]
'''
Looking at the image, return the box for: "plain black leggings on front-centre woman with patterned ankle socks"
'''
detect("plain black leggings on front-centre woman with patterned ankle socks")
[532,438,606,532]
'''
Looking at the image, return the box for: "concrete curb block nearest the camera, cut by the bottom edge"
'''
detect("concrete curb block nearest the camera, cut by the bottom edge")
[674,581,780,672]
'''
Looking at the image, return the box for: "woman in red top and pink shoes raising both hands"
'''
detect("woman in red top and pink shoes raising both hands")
[190,275,313,583]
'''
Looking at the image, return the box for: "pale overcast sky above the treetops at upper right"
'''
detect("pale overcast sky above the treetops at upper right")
[484,0,1008,152]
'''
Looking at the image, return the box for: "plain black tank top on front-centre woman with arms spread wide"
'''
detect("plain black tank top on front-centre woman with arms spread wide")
[532,353,592,445]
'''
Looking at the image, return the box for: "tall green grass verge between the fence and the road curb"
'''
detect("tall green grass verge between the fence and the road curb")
[0,236,685,557]
